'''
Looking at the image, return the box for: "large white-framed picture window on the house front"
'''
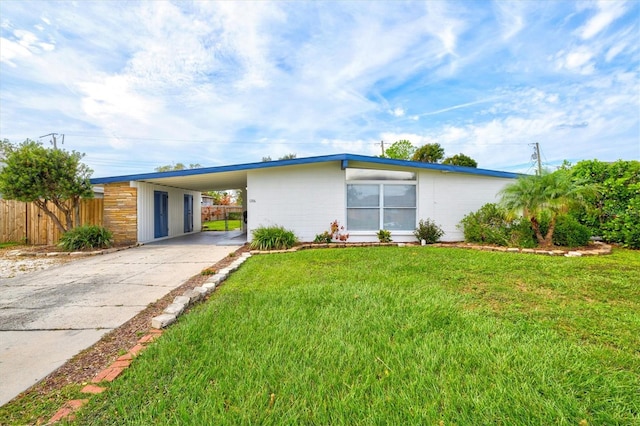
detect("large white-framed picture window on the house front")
[347,183,416,231]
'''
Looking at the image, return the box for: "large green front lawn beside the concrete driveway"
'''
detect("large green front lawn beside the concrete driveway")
[60,247,640,425]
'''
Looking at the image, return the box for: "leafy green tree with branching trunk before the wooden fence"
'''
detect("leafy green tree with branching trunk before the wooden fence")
[0,139,93,232]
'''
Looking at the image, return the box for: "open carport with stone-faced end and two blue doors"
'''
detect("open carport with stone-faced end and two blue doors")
[91,164,256,245]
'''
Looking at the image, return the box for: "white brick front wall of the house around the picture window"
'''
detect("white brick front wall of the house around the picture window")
[246,163,513,242]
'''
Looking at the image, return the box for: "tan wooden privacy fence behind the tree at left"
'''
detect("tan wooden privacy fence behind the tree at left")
[0,198,104,245]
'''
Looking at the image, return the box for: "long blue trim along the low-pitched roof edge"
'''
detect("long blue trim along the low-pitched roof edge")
[91,154,520,185]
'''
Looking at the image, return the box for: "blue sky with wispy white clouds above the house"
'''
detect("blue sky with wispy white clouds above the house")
[0,0,640,177]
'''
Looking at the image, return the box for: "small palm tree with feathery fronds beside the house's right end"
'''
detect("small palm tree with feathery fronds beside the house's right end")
[500,170,593,247]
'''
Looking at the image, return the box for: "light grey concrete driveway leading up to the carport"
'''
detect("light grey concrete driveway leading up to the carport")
[0,232,244,406]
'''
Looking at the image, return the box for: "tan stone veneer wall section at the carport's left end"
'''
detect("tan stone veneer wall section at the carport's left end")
[103,182,138,245]
